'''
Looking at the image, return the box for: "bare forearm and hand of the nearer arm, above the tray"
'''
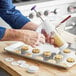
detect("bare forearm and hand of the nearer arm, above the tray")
[1,29,45,47]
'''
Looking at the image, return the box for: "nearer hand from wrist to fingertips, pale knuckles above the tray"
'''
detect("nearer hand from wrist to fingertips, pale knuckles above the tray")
[17,30,45,47]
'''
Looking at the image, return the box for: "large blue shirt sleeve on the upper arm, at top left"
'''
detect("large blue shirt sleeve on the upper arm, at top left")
[0,0,30,29]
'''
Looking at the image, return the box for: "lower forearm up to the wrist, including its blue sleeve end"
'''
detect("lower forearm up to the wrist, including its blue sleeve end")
[0,27,20,41]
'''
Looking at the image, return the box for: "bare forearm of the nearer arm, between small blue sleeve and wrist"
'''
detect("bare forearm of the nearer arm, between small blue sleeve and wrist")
[1,29,19,41]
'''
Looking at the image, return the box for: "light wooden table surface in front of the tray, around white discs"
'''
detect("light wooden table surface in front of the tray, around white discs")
[0,42,76,76]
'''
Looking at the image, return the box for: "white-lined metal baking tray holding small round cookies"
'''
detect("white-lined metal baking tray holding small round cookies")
[4,42,76,69]
